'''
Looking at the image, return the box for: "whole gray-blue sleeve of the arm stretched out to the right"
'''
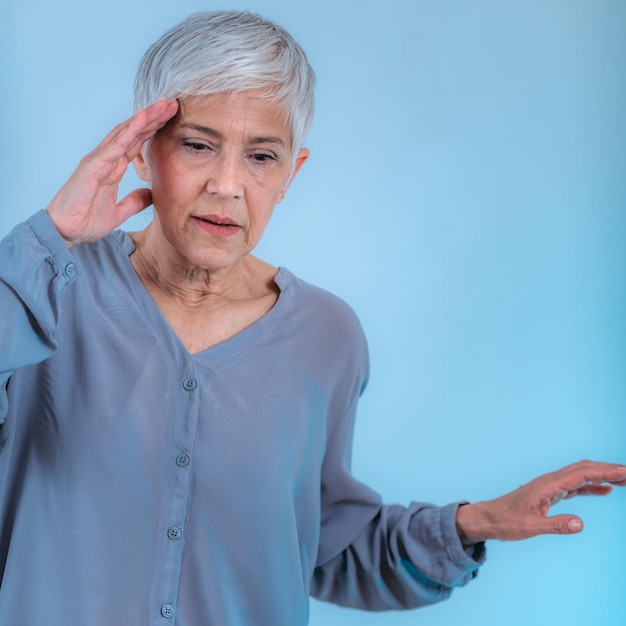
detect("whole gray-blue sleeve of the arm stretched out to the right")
[311,386,484,611]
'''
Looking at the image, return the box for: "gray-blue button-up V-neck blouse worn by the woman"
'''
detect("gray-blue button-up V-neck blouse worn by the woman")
[0,211,484,626]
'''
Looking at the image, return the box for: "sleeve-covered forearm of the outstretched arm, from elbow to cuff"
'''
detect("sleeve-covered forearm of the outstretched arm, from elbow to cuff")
[311,503,484,611]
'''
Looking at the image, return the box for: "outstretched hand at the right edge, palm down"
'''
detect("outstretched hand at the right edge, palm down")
[456,461,626,545]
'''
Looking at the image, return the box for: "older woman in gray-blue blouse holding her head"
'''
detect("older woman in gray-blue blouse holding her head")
[0,12,626,626]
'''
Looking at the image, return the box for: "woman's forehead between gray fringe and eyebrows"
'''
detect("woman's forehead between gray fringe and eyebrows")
[174,90,291,145]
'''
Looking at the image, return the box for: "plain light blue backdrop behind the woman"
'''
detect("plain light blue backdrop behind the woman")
[0,0,626,626]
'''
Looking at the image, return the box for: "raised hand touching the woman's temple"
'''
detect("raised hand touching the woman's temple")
[46,100,178,247]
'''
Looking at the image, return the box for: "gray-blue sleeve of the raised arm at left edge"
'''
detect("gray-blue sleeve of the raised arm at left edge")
[0,211,78,422]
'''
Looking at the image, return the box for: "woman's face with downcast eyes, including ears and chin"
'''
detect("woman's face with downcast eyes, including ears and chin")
[135,91,308,271]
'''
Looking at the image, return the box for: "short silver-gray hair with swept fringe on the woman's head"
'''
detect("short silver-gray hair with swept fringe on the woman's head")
[135,11,315,154]
